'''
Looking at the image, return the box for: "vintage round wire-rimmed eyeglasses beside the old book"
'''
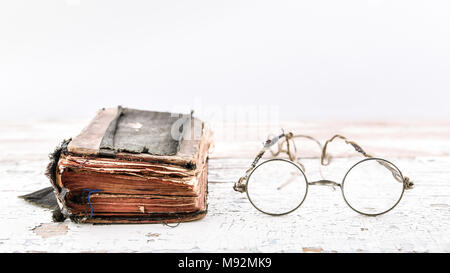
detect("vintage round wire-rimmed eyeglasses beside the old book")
[233,132,414,216]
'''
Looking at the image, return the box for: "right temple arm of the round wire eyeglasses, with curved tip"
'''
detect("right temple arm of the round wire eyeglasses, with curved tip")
[320,135,414,189]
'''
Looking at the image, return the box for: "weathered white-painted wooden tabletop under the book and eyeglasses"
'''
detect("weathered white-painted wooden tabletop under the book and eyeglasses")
[0,120,450,252]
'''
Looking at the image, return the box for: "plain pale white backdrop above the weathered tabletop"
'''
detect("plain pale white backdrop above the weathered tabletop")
[0,0,450,119]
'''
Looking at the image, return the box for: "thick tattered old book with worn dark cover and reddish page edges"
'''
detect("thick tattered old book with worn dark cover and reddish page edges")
[48,107,212,223]
